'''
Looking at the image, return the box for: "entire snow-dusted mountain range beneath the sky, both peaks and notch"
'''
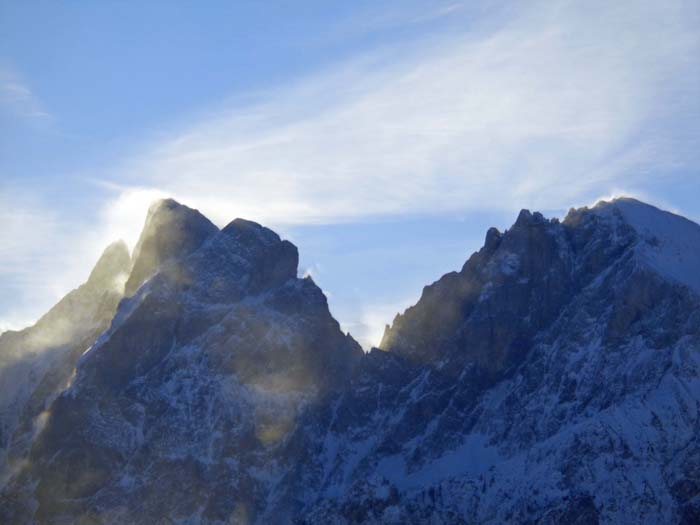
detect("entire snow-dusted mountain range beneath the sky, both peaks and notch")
[0,198,700,525]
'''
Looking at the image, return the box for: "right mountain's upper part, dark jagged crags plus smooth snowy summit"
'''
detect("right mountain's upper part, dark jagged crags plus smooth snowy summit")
[381,198,700,366]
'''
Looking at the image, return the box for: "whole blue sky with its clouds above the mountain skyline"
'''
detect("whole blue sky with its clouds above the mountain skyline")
[0,0,700,345]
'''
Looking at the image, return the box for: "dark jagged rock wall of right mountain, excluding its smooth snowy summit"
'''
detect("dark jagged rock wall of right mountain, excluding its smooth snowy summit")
[380,205,634,375]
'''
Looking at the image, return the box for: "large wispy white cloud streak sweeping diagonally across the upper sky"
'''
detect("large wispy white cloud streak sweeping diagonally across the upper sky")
[102,2,700,224]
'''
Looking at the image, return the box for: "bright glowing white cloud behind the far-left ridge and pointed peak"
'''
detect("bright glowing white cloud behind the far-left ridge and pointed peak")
[0,185,164,332]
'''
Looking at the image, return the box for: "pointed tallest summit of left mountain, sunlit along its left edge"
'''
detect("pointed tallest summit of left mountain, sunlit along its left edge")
[125,199,219,296]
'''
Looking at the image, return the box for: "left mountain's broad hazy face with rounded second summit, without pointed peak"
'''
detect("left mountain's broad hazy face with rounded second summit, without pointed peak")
[0,202,362,523]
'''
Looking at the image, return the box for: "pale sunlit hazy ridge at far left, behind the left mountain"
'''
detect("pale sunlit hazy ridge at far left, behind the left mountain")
[0,242,130,478]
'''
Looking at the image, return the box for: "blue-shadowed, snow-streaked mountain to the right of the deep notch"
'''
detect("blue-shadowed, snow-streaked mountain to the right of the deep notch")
[304,200,700,523]
